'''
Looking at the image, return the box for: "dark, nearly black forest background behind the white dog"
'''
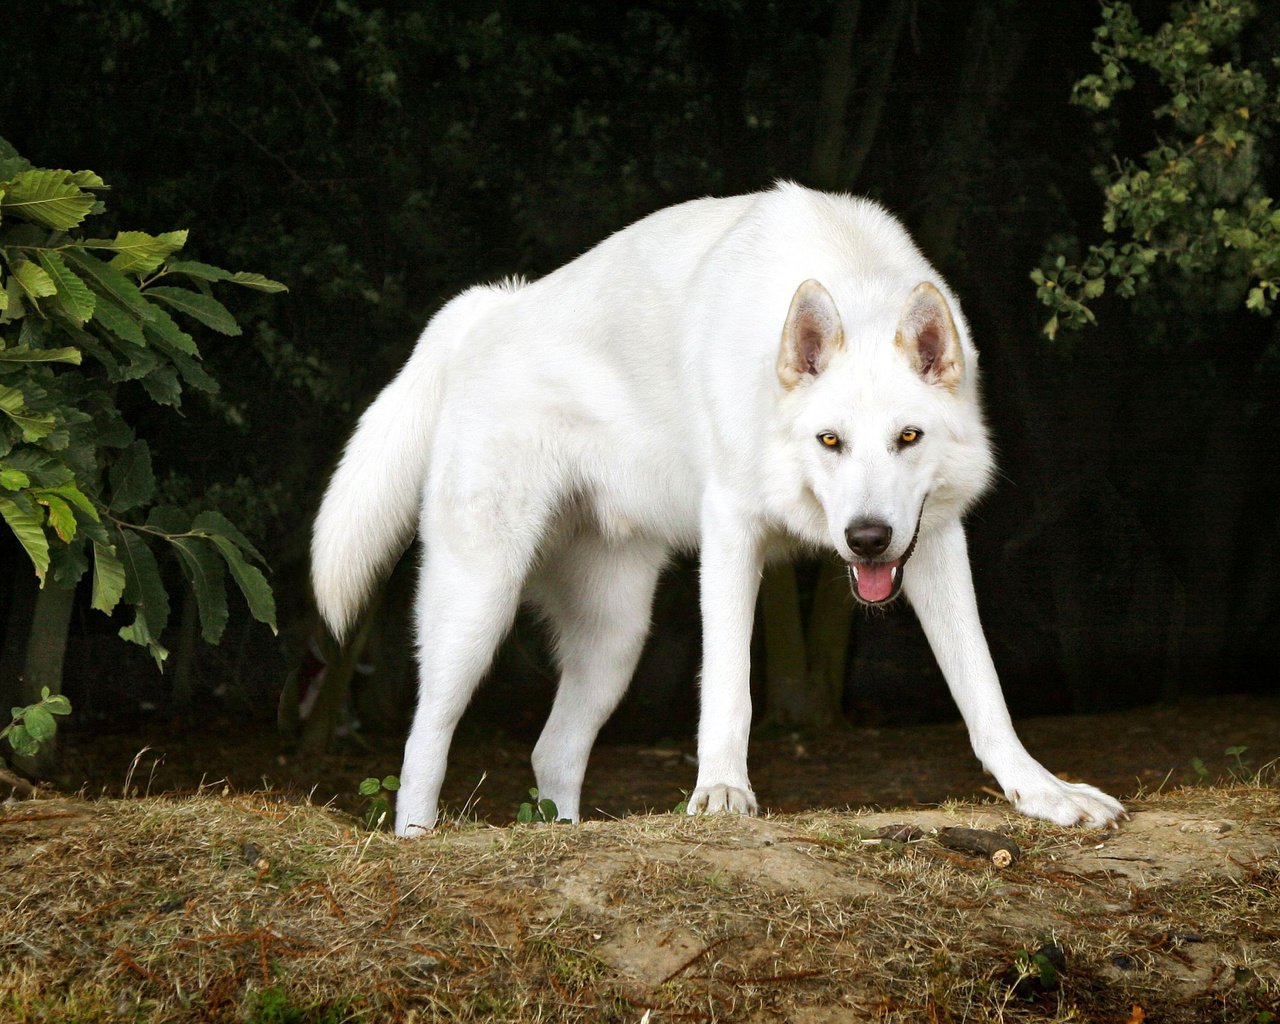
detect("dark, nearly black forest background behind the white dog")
[0,0,1280,757]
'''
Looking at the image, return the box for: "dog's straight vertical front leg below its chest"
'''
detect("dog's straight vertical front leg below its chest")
[689,492,764,814]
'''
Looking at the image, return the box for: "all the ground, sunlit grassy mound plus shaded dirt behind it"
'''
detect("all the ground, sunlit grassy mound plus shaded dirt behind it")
[0,698,1280,1024]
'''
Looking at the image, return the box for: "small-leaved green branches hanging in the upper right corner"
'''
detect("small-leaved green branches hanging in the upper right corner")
[1032,0,1280,338]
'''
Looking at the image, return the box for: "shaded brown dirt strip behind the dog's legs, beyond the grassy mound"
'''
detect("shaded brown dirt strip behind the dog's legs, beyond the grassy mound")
[58,696,1280,824]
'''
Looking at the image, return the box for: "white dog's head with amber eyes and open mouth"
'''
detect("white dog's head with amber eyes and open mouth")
[777,280,991,604]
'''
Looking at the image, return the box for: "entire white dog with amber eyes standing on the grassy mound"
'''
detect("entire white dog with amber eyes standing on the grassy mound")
[312,184,1124,835]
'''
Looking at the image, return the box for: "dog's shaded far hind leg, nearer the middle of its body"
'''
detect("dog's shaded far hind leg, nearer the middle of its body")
[530,536,667,822]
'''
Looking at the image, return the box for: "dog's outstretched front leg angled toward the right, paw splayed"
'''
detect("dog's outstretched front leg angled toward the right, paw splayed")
[902,520,1125,828]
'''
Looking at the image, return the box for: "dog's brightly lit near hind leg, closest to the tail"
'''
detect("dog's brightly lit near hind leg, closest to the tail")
[396,476,545,836]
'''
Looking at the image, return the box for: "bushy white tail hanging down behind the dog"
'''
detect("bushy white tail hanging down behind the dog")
[311,287,502,640]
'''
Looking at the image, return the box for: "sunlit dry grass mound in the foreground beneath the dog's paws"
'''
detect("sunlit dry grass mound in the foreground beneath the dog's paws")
[0,785,1280,1024]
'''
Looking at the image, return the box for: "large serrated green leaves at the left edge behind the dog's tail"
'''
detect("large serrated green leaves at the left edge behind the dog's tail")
[0,140,284,664]
